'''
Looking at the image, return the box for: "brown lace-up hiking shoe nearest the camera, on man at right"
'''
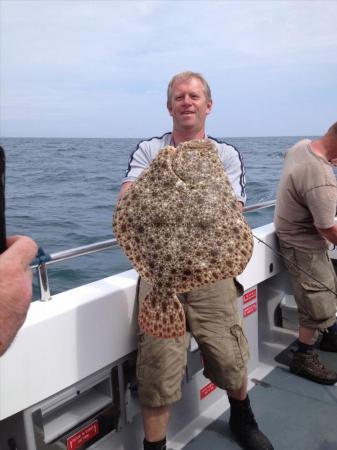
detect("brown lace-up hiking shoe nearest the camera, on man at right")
[289,352,337,384]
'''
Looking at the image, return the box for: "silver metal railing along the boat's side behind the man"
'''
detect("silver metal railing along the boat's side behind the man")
[31,200,276,302]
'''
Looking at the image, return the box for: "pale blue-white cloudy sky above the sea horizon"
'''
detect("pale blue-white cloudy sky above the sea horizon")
[0,0,337,137]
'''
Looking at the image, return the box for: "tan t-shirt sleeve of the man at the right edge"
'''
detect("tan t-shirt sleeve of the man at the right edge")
[306,185,337,229]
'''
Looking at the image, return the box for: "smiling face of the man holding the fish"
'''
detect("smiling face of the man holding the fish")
[168,78,212,132]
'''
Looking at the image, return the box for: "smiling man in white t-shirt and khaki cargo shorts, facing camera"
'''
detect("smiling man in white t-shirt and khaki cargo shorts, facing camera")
[117,72,273,450]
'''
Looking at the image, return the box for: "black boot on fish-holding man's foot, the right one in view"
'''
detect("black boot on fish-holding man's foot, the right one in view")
[228,396,274,450]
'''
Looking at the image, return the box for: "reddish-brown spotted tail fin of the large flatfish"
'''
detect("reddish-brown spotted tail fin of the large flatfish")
[138,289,186,339]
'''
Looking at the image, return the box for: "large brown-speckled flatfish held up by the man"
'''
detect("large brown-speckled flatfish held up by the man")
[113,139,253,338]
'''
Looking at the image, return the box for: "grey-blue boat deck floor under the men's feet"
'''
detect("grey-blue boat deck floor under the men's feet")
[183,345,337,450]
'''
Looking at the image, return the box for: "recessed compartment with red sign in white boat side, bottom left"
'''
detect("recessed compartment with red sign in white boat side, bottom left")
[24,366,120,450]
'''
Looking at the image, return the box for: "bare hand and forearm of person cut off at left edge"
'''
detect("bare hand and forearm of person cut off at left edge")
[0,236,37,356]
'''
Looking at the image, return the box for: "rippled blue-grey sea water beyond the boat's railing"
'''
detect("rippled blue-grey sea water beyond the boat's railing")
[0,136,312,298]
